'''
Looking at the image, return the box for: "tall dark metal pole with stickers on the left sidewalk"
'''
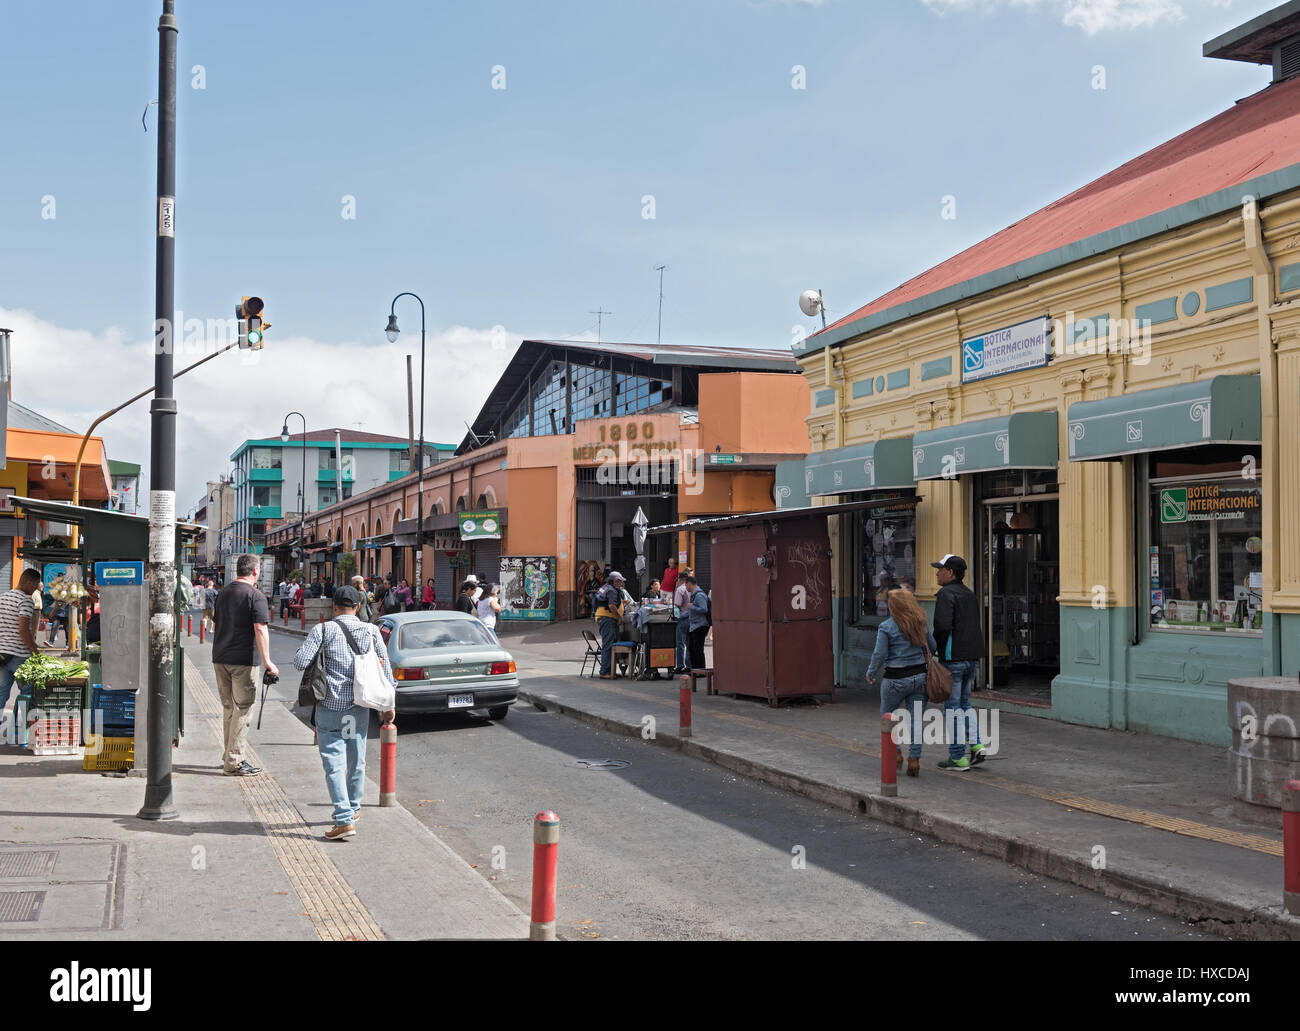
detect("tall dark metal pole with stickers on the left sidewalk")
[138,0,181,820]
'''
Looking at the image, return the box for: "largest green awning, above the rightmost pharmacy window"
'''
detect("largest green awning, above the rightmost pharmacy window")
[1069,376,1262,462]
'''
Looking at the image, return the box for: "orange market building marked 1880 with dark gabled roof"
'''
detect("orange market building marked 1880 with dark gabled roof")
[267,341,811,619]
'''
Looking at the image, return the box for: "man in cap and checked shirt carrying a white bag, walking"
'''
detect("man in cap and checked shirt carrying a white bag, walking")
[294,586,397,841]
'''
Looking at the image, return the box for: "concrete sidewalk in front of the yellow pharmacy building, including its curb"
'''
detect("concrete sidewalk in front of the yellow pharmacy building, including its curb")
[503,623,1300,939]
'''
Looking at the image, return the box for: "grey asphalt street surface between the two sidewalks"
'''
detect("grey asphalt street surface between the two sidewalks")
[258,633,1210,940]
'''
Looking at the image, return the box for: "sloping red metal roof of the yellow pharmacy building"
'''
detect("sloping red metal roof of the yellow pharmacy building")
[807,79,1300,351]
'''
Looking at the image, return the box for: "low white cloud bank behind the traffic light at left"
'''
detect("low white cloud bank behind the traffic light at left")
[0,308,521,514]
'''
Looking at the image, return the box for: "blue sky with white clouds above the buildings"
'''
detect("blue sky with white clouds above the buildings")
[0,0,1273,515]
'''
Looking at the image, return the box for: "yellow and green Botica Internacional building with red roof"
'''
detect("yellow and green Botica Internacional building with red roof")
[779,8,1300,744]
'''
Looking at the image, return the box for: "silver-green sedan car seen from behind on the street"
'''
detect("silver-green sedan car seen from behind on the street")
[376,610,519,720]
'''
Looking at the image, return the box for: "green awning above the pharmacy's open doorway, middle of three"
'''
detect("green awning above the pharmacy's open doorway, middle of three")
[911,412,1057,480]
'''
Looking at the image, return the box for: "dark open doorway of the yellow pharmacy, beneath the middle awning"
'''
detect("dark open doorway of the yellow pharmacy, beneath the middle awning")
[976,471,1061,707]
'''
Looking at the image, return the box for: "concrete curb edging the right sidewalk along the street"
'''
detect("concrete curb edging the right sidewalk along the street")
[519,686,1300,941]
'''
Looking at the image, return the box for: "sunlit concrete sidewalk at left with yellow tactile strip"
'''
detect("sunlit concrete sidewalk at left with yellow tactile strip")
[0,637,528,940]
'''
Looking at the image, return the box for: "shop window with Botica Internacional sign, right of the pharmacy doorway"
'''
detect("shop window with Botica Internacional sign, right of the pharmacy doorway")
[1148,465,1264,633]
